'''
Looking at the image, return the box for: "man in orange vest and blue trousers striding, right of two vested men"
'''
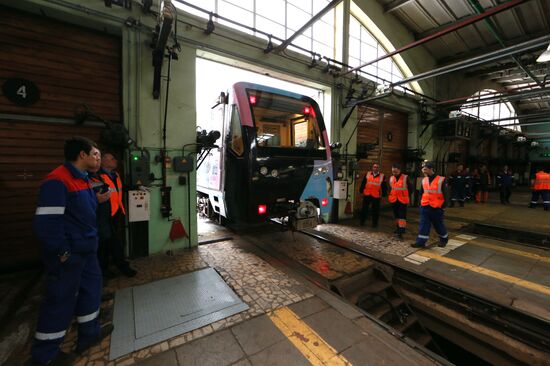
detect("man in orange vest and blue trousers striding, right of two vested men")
[411,161,449,248]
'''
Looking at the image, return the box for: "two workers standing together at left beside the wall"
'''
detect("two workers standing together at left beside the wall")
[31,137,136,365]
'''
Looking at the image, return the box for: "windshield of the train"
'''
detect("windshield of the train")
[248,90,325,150]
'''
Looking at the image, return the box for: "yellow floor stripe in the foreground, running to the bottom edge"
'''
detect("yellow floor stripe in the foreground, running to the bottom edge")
[268,306,351,366]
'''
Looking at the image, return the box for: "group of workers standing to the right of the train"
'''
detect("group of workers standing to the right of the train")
[359,161,550,248]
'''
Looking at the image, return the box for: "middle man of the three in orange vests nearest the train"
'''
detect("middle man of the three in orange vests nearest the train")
[388,164,412,239]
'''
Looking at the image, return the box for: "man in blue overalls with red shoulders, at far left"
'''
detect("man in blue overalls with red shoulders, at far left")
[31,137,112,365]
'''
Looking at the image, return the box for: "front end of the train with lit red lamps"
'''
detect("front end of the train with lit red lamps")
[234,83,333,229]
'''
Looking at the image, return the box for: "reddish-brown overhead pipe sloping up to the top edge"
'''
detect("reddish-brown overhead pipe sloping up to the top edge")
[342,0,529,75]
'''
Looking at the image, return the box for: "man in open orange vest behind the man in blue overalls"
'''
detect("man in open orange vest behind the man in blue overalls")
[99,152,136,277]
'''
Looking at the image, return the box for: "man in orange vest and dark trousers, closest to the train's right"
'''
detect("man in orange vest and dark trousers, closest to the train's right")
[359,163,387,227]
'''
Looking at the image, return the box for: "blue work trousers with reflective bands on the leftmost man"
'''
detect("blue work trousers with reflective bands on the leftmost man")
[31,251,102,363]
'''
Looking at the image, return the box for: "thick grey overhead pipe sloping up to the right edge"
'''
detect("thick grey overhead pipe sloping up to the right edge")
[391,35,550,86]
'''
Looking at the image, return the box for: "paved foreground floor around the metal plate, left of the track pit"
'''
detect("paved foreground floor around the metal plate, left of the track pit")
[0,227,438,366]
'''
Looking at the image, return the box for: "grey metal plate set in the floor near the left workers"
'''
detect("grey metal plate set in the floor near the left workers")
[109,268,248,360]
